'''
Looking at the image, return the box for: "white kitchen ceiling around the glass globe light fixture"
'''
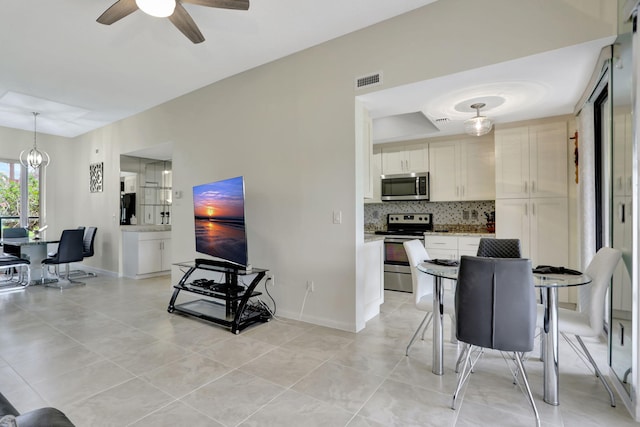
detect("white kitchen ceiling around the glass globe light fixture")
[358,38,614,143]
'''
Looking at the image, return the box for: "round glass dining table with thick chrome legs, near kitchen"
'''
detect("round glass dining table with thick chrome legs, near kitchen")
[418,261,591,405]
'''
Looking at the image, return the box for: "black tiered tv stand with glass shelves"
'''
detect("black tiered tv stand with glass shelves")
[167,258,271,334]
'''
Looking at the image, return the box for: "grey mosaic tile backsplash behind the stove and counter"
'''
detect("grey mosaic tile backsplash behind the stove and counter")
[364,200,496,231]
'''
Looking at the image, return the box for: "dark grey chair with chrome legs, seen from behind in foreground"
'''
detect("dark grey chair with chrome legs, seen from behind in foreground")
[451,255,540,426]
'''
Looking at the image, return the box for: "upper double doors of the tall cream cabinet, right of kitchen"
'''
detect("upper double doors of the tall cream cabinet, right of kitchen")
[495,121,568,199]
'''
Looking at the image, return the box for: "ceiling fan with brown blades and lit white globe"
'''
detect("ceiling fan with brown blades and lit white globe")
[97,0,249,43]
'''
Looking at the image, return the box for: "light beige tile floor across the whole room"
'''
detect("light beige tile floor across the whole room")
[0,277,636,427]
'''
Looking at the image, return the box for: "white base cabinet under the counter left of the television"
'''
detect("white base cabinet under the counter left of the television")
[122,231,171,279]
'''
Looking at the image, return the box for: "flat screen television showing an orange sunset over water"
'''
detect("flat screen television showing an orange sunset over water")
[193,176,248,267]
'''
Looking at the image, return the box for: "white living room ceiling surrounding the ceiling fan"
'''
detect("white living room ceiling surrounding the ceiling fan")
[0,0,435,137]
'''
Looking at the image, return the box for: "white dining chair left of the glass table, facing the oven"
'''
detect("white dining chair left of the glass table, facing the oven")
[403,239,455,356]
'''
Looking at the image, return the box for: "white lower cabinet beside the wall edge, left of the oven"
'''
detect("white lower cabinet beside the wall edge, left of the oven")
[364,240,384,322]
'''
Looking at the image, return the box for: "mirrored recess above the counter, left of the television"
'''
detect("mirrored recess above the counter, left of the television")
[120,155,172,225]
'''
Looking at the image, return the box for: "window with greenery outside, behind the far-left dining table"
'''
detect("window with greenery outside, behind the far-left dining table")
[0,159,41,234]
